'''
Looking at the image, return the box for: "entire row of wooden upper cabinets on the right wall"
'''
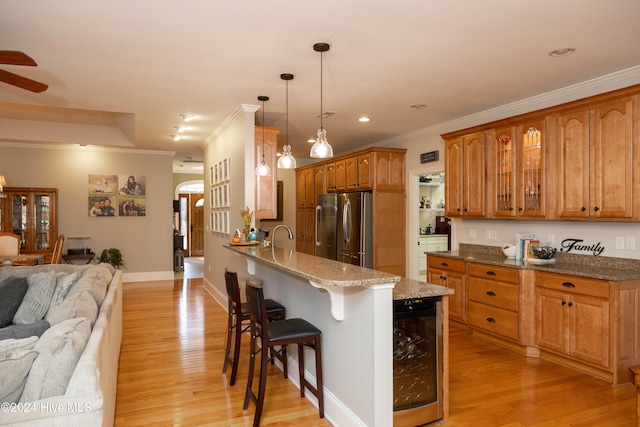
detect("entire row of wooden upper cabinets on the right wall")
[442,85,640,221]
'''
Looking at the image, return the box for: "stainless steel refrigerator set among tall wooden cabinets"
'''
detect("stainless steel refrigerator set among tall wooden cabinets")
[316,192,373,268]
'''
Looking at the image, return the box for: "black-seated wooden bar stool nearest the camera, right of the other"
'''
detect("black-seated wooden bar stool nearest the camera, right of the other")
[242,282,324,427]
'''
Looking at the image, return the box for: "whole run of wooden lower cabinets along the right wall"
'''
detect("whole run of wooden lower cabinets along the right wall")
[427,260,640,385]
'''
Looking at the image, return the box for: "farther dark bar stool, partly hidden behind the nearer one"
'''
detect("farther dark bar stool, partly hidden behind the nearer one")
[222,268,286,386]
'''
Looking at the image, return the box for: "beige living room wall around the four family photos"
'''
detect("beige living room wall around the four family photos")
[0,143,173,281]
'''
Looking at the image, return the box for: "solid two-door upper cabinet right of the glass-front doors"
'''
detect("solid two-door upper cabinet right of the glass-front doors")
[555,96,640,220]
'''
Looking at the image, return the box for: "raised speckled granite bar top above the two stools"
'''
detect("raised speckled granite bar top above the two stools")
[224,244,401,288]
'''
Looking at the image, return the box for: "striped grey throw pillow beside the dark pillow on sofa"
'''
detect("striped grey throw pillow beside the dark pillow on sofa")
[13,270,56,325]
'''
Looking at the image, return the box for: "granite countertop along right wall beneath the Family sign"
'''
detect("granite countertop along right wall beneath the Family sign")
[427,244,640,282]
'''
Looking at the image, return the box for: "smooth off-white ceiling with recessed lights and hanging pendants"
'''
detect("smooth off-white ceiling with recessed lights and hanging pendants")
[0,0,640,172]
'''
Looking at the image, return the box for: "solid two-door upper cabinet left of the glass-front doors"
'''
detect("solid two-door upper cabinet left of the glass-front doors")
[444,132,486,218]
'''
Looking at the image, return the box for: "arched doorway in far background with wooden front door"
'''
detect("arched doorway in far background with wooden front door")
[174,180,204,257]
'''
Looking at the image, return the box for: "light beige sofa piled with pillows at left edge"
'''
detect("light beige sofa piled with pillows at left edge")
[0,264,122,427]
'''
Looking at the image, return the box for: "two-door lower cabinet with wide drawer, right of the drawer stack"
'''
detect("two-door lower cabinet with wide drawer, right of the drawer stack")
[536,273,614,369]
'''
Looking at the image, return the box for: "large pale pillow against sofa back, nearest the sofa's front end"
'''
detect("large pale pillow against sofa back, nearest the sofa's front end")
[20,317,91,402]
